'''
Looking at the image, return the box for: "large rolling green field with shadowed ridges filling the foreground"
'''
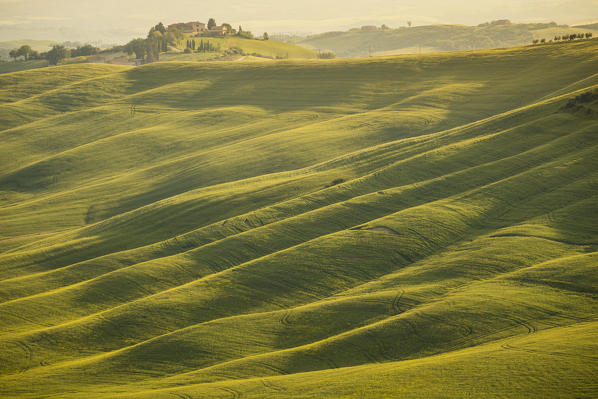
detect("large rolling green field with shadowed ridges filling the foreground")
[0,40,598,398]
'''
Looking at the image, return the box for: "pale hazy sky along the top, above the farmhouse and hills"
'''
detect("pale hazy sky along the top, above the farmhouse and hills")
[0,0,598,43]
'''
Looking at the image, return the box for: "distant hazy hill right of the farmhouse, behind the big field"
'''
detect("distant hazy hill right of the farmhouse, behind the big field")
[298,23,598,57]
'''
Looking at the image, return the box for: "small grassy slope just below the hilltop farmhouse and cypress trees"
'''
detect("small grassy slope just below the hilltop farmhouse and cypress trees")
[160,36,317,61]
